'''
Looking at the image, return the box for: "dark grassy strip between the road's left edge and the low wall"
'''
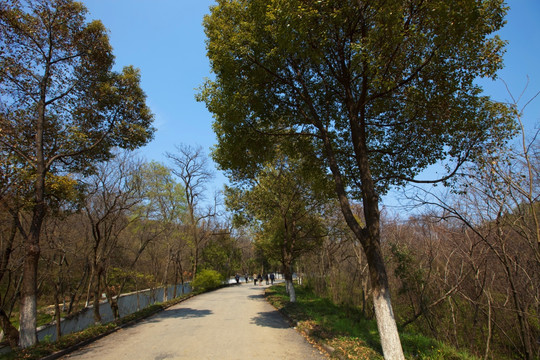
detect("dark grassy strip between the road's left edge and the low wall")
[0,293,195,360]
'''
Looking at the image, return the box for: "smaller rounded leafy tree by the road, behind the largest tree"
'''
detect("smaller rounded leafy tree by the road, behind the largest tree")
[227,157,327,302]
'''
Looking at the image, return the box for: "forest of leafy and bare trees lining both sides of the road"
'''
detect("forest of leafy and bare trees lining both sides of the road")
[0,0,540,360]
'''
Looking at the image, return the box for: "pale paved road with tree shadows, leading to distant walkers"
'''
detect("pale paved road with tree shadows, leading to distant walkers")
[63,283,325,360]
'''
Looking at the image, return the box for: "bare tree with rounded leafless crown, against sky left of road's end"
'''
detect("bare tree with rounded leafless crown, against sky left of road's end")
[166,145,215,276]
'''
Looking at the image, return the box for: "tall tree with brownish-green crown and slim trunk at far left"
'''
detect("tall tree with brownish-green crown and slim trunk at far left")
[0,0,153,347]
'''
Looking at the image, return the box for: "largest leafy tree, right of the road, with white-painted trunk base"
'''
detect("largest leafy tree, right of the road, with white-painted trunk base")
[200,0,511,359]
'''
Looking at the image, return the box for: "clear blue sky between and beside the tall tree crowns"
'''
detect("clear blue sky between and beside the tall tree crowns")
[82,0,540,202]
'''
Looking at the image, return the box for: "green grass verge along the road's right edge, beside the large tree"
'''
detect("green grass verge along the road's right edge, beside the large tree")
[266,284,478,360]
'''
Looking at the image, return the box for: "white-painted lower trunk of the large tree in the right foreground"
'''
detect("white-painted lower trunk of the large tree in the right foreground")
[373,289,405,360]
